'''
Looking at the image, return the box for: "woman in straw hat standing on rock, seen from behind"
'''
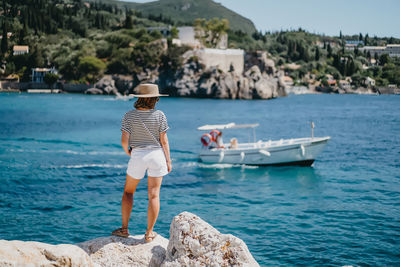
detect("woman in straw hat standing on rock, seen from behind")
[112,84,172,242]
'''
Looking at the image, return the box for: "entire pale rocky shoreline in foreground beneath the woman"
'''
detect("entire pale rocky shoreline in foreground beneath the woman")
[0,212,259,267]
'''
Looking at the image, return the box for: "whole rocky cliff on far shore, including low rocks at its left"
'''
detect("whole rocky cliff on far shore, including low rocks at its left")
[86,52,286,99]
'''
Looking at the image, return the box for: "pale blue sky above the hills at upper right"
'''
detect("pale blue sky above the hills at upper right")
[125,0,400,38]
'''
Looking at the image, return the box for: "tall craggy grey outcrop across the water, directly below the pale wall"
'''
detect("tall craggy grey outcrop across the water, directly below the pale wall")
[162,54,286,99]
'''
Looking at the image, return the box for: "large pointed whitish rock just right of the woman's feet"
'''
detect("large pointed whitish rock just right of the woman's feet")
[162,212,259,267]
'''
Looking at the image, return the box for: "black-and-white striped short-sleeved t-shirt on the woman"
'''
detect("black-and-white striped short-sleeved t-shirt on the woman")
[121,109,169,149]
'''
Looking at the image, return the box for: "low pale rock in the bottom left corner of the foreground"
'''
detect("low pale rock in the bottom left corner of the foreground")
[0,240,94,267]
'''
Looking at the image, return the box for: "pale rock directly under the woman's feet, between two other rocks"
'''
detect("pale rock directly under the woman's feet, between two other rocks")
[77,235,168,267]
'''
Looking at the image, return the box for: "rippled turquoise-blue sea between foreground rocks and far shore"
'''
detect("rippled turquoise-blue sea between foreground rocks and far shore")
[0,94,400,266]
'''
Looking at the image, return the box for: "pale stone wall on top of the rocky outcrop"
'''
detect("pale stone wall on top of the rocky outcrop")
[194,48,244,74]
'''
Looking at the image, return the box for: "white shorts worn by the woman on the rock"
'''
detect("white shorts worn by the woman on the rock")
[126,148,168,179]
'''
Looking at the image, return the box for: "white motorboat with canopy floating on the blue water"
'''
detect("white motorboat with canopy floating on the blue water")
[197,123,330,166]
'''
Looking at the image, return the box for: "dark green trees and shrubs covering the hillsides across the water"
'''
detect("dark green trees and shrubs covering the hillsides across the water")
[0,0,400,89]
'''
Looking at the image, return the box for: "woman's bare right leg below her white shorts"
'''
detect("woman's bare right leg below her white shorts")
[146,176,162,235]
